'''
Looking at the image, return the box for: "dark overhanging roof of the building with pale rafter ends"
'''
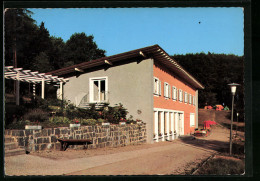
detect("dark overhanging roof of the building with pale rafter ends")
[46,45,204,89]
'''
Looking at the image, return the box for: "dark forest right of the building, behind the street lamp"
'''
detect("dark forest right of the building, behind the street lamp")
[172,53,244,115]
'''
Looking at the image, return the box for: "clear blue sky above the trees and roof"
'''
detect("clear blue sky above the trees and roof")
[29,7,244,56]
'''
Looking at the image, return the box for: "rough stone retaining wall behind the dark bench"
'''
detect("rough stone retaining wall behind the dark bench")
[5,123,146,152]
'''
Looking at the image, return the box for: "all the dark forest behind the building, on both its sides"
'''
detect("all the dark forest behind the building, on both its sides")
[4,9,244,112]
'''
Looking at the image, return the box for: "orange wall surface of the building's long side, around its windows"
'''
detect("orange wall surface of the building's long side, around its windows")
[153,62,197,135]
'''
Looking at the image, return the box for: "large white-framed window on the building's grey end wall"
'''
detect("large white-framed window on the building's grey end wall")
[89,77,108,102]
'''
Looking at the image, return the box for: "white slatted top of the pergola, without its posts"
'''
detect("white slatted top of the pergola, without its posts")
[4,66,69,83]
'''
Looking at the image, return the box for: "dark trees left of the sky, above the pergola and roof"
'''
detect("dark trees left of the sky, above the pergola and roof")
[4,8,105,72]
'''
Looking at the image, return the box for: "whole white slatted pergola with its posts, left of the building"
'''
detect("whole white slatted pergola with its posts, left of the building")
[4,66,69,105]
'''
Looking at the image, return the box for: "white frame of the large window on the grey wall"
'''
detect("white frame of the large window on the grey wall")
[89,76,108,103]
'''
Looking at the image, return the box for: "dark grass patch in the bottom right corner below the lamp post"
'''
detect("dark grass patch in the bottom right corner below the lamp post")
[196,157,245,175]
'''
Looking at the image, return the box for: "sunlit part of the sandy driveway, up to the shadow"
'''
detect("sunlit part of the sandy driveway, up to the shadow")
[5,126,230,175]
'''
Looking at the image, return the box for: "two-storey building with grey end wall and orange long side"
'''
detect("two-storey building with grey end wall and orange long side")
[48,45,204,143]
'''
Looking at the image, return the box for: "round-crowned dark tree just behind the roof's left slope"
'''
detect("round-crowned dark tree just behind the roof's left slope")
[63,33,105,66]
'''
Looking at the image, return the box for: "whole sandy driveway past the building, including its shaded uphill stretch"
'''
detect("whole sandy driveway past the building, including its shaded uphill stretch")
[5,127,229,175]
